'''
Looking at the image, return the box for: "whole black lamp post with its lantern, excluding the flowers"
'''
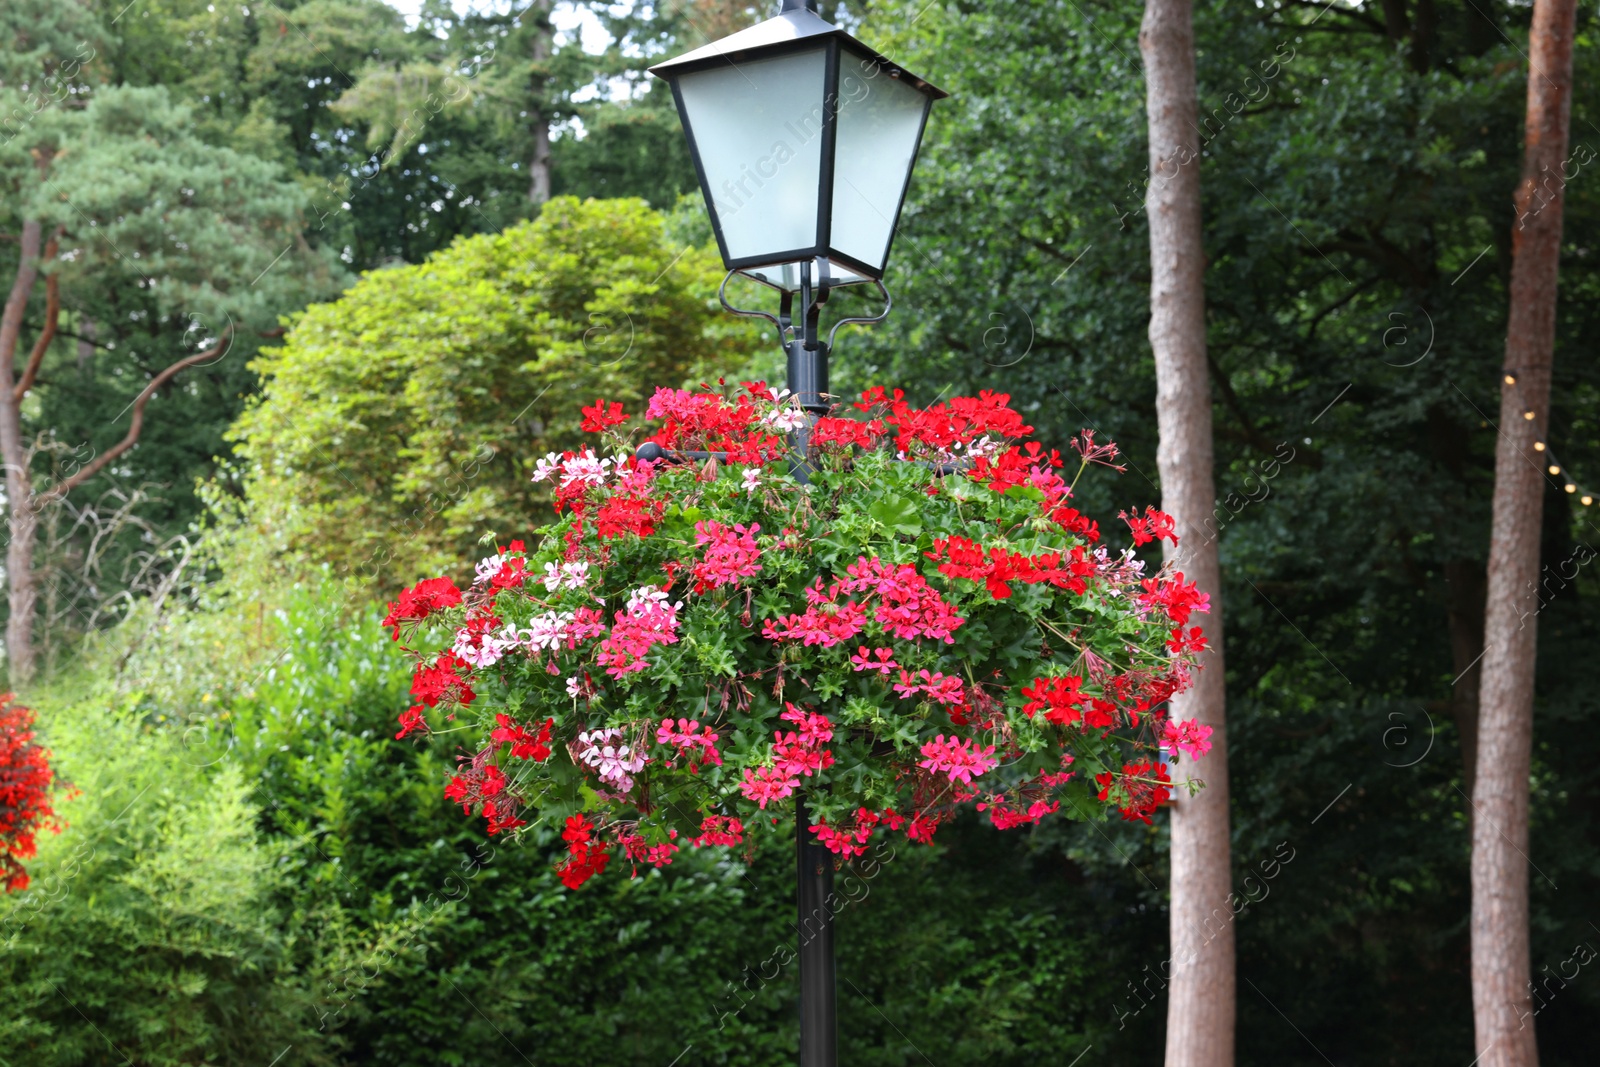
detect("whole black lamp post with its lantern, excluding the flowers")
[642,10,946,1067]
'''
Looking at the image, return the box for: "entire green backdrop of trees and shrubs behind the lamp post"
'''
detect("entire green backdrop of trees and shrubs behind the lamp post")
[0,0,1600,1067]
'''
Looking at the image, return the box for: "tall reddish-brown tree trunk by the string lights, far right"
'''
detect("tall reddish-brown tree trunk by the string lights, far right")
[1472,0,1574,1067]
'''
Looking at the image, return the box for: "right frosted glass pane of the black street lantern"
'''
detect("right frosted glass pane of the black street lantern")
[832,50,931,270]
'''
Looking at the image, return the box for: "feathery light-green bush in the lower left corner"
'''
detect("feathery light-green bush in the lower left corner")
[0,701,306,1067]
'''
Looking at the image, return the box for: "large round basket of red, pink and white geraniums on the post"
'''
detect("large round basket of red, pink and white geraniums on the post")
[384,382,1211,888]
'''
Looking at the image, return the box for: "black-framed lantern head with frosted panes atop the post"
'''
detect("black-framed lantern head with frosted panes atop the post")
[650,0,946,291]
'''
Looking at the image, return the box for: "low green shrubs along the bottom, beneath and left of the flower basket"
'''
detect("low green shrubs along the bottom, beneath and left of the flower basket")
[0,585,1136,1067]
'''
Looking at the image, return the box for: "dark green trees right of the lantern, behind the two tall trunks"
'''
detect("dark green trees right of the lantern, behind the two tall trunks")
[857,0,1600,1065]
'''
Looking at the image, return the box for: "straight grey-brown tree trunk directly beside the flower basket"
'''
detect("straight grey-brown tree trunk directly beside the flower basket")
[1139,0,1234,1067]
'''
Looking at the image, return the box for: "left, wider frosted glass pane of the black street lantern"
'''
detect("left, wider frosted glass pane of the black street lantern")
[678,48,827,259]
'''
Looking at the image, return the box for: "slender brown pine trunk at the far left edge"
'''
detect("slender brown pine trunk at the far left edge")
[0,219,43,686]
